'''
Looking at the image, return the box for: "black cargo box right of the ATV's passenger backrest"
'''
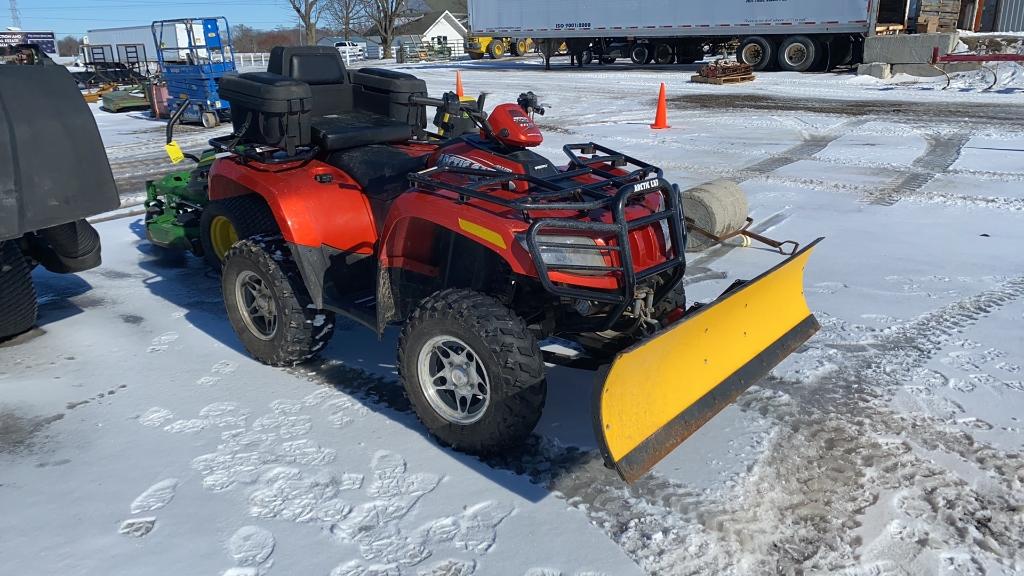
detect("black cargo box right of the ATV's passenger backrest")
[349,68,427,128]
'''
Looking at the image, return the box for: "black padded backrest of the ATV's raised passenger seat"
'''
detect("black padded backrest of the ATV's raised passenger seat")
[267,46,352,117]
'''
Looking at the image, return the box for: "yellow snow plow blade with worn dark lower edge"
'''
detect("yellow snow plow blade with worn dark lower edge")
[594,238,821,483]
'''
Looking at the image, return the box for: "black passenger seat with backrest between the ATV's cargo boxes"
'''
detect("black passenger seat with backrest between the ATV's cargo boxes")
[267,46,414,152]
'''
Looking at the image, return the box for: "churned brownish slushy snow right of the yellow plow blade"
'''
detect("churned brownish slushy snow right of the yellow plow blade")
[654,278,1024,574]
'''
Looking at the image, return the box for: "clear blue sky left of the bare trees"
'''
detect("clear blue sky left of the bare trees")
[0,0,297,38]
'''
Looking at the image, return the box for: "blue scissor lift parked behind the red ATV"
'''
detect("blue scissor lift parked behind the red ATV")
[151,16,236,128]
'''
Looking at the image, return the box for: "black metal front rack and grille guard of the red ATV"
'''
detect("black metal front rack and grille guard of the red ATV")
[409,142,686,331]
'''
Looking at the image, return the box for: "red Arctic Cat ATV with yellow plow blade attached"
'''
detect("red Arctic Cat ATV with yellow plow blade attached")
[146,47,818,482]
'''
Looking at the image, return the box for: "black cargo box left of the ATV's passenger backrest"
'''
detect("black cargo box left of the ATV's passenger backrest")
[219,72,313,155]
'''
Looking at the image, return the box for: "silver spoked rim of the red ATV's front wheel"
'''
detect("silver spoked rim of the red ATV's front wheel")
[417,336,490,425]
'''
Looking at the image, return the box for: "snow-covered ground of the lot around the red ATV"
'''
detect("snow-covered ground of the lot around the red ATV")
[0,60,1024,576]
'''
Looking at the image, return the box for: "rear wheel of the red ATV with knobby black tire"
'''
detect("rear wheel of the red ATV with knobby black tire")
[221,236,334,366]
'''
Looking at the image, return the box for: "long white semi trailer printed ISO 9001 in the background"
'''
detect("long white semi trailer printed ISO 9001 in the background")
[469,0,909,72]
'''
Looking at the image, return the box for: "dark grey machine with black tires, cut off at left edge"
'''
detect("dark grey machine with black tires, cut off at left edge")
[0,44,120,339]
